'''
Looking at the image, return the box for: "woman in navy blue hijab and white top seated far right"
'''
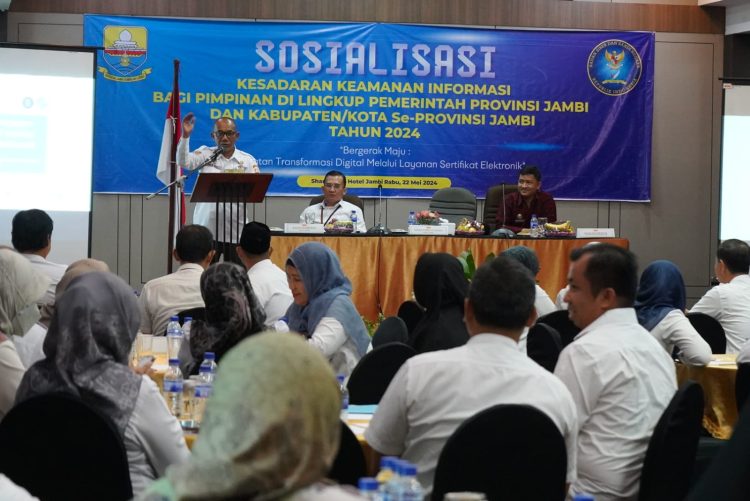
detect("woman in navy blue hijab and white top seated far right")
[635,260,713,366]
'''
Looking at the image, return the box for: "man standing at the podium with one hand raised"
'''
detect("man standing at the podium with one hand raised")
[177,113,260,264]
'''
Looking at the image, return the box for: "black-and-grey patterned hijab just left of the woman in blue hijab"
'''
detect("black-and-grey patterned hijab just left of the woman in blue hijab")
[190,262,266,372]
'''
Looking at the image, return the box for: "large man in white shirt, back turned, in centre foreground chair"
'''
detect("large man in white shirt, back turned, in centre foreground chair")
[365,256,577,494]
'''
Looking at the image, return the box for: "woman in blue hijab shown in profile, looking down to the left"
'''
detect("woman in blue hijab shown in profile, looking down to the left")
[286,242,370,376]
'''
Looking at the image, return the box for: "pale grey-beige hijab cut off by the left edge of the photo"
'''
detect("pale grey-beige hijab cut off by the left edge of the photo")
[0,247,50,336]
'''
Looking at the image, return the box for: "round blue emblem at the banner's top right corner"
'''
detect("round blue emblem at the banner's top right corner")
[588,40,643,96]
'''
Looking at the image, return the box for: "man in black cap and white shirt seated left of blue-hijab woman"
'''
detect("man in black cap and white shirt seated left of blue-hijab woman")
[237,221,294,327]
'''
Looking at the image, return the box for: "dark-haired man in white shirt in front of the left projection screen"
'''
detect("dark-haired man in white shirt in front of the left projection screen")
[11,209,67,306]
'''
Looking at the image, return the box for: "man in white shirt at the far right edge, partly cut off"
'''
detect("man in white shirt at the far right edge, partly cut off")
[690,239,750,353]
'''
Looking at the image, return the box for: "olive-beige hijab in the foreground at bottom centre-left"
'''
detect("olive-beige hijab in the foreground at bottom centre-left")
[143,332,341,500]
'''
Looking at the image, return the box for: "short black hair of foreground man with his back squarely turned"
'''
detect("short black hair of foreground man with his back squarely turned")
[468,256,536,329]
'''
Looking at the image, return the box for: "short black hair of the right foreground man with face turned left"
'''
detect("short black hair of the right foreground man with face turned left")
[570,244,638,308]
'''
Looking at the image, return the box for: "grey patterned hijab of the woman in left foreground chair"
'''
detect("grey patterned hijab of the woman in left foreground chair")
[16,272,141,436]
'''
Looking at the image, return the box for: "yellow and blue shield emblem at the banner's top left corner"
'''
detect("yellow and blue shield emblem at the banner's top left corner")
[98,26,151,82]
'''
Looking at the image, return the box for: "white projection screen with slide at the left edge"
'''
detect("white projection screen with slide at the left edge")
[0,44,94,263]
